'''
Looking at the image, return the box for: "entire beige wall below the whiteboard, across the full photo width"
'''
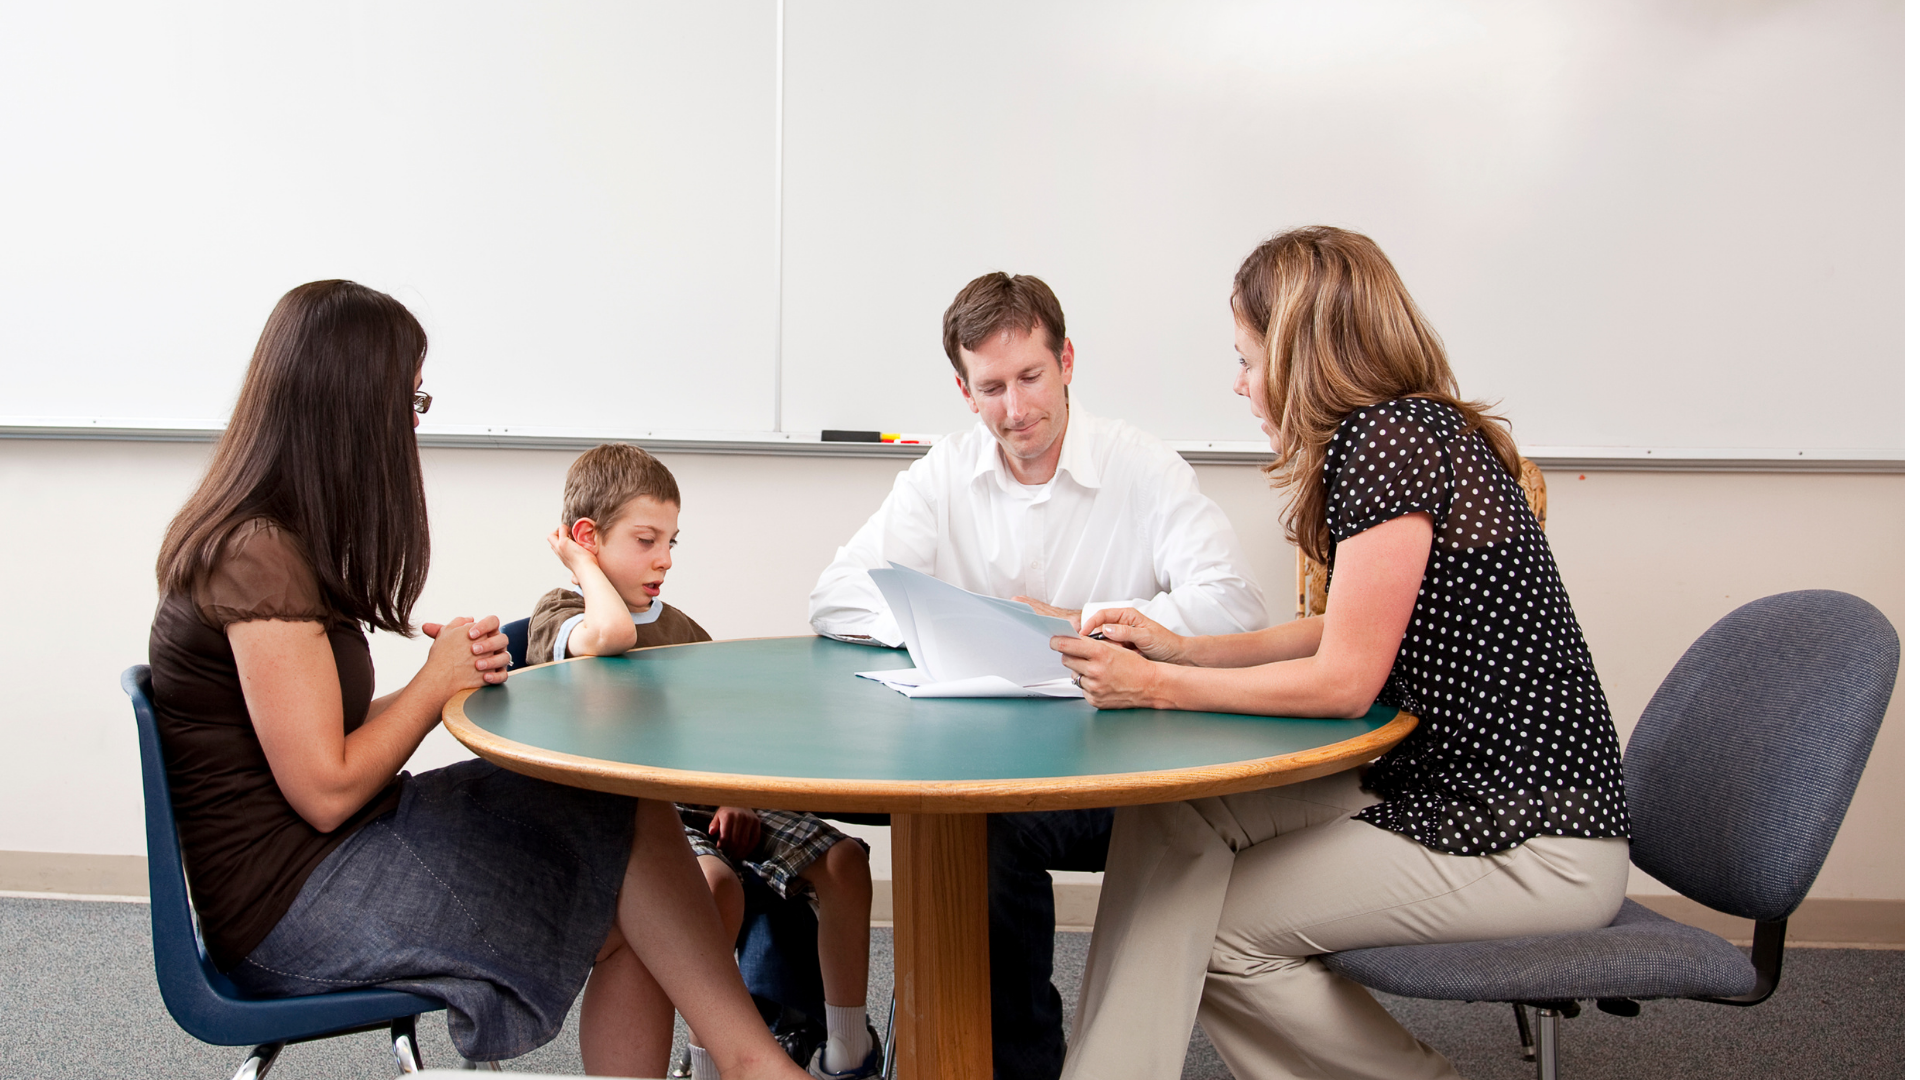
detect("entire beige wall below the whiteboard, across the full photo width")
[0,440,1905,899]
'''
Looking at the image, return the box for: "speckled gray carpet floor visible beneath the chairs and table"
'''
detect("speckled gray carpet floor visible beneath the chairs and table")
[0,897,1905,1080]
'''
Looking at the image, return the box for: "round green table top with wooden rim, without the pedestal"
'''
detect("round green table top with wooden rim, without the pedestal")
[447,638,1411,809]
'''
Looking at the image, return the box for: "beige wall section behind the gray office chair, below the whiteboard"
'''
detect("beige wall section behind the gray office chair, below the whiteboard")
[1512,473,1907,899]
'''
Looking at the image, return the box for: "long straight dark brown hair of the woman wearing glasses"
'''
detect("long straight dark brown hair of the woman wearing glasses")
[156,281,428,634]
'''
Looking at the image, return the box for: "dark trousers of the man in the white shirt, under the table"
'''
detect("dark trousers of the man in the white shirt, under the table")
[987,809,1114,1080]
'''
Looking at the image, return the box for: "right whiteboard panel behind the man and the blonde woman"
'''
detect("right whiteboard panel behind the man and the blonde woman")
[783,0,1903,455]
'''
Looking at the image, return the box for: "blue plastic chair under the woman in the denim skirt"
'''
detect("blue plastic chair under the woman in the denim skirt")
[121,663,444,1080]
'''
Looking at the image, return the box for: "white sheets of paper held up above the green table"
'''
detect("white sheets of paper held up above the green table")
[858,563,1083,698]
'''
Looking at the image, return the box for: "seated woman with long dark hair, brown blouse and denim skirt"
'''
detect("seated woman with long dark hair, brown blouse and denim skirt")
[148,281,804,1078]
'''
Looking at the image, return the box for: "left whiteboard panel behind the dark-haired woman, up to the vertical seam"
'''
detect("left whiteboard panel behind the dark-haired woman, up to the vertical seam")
[0,0,778,432]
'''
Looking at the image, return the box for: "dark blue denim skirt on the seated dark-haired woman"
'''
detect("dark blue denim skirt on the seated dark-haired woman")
[228,761,634,1061]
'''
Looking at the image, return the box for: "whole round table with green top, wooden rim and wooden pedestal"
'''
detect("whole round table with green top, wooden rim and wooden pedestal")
[444,638,1415,1080]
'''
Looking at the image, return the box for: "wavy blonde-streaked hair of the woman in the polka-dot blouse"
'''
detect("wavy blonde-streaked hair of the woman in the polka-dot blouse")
[1233,225,1521,563]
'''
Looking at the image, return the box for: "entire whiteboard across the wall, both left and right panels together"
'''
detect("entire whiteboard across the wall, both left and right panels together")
[0,0,1903,457]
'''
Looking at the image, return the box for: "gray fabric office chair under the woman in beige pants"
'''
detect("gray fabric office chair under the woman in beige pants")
[1321,590,1901,1080]
